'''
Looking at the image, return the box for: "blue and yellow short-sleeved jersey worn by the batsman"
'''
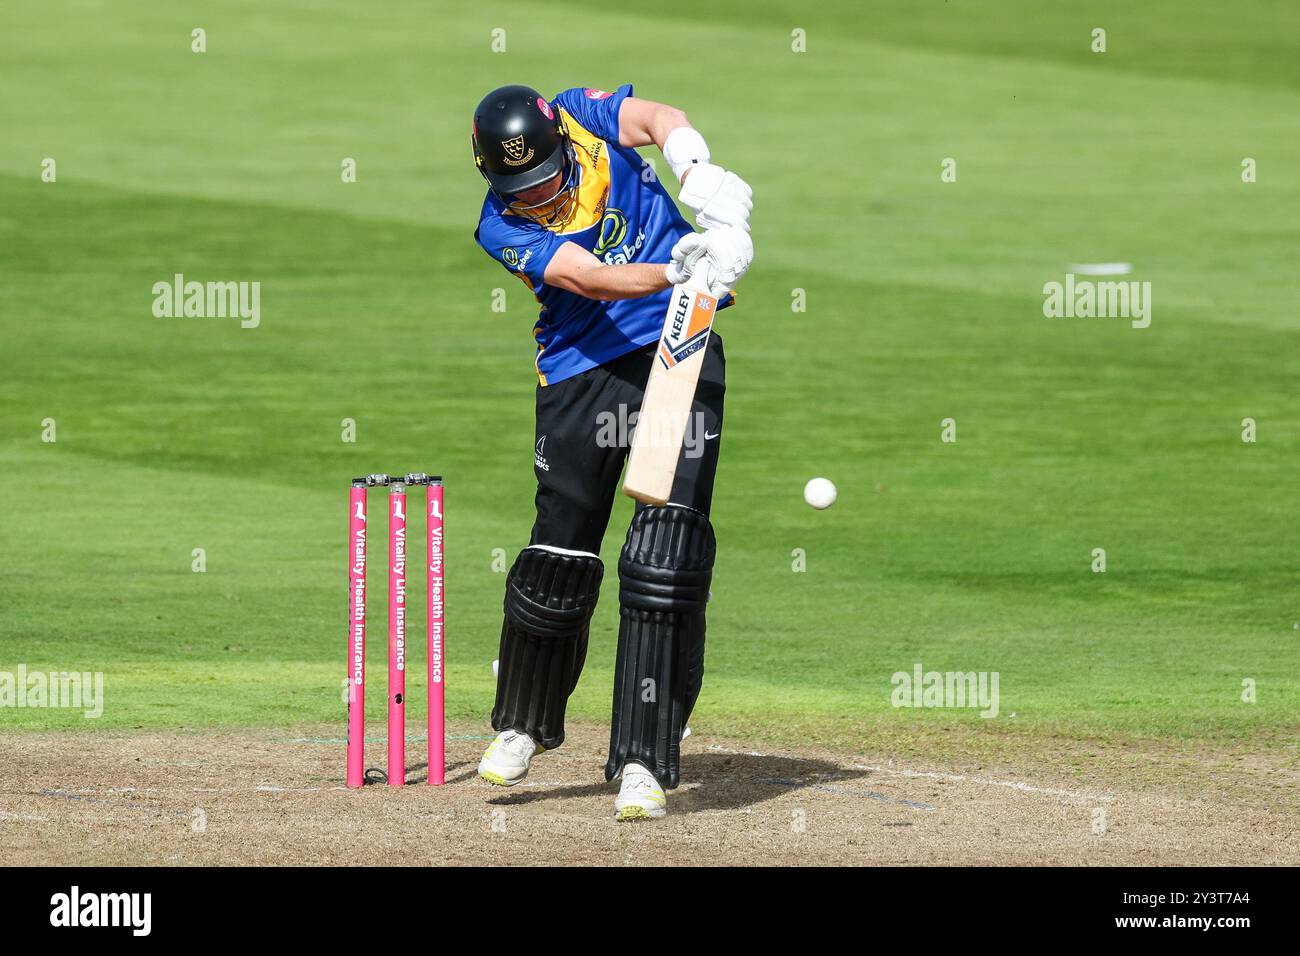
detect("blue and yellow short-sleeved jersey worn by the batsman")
[475,85,731,385]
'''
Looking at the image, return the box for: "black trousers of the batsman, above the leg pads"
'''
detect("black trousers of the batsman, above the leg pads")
[529,332,727,554]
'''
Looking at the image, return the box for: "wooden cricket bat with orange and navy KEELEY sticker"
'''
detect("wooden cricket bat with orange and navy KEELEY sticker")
[623,259,718,505]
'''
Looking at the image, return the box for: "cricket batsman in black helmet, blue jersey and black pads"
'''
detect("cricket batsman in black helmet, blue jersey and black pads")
[473,86,754,819]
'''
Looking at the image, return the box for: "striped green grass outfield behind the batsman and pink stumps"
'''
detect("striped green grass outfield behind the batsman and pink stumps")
[0,0,1300,749]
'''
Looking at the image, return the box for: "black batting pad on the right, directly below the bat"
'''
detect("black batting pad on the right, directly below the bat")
[605,505,715,790]
